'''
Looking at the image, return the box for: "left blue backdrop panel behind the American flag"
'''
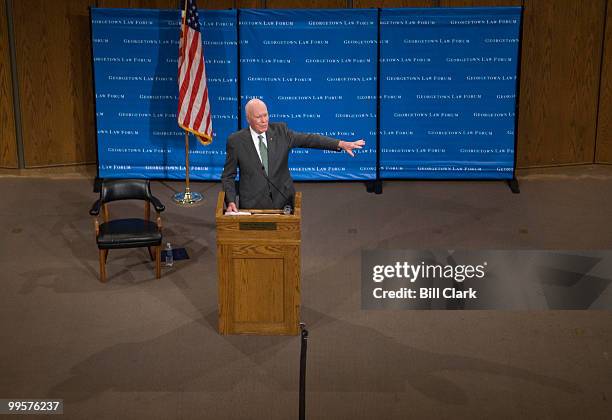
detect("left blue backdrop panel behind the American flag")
[91,9,238,180]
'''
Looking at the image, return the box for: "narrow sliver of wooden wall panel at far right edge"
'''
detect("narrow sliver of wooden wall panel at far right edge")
[595,0,612,163]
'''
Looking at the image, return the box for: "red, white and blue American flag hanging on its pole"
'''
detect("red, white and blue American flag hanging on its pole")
[178,0,212,144]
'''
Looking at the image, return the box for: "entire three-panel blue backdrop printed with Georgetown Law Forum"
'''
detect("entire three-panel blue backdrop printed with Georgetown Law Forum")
[92,8,521,180]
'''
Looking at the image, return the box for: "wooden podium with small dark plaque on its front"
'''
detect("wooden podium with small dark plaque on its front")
[215,192,302,335]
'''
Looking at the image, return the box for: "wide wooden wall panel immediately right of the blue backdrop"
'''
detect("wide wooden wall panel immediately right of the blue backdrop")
[517,0,605,167]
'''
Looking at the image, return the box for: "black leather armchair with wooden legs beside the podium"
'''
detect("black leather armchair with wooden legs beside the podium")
[89,179,165,283]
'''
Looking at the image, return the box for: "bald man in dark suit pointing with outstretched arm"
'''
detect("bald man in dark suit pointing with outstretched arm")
[221,99,365,211]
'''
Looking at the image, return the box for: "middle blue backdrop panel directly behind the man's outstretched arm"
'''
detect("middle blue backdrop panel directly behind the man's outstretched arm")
[240,9,378,180]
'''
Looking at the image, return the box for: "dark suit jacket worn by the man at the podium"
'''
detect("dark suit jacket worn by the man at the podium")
[221,123,339,209]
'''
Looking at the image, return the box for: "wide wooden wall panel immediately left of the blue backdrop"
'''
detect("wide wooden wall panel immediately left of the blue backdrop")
[13,0,96,167]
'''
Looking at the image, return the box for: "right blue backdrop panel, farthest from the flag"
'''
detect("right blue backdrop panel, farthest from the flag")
[380,7,521,178]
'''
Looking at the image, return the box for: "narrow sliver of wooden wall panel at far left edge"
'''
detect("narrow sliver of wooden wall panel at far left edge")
[0,1,19,168]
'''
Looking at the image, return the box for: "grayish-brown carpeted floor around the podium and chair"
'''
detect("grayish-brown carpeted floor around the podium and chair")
[0,166,612,419]
